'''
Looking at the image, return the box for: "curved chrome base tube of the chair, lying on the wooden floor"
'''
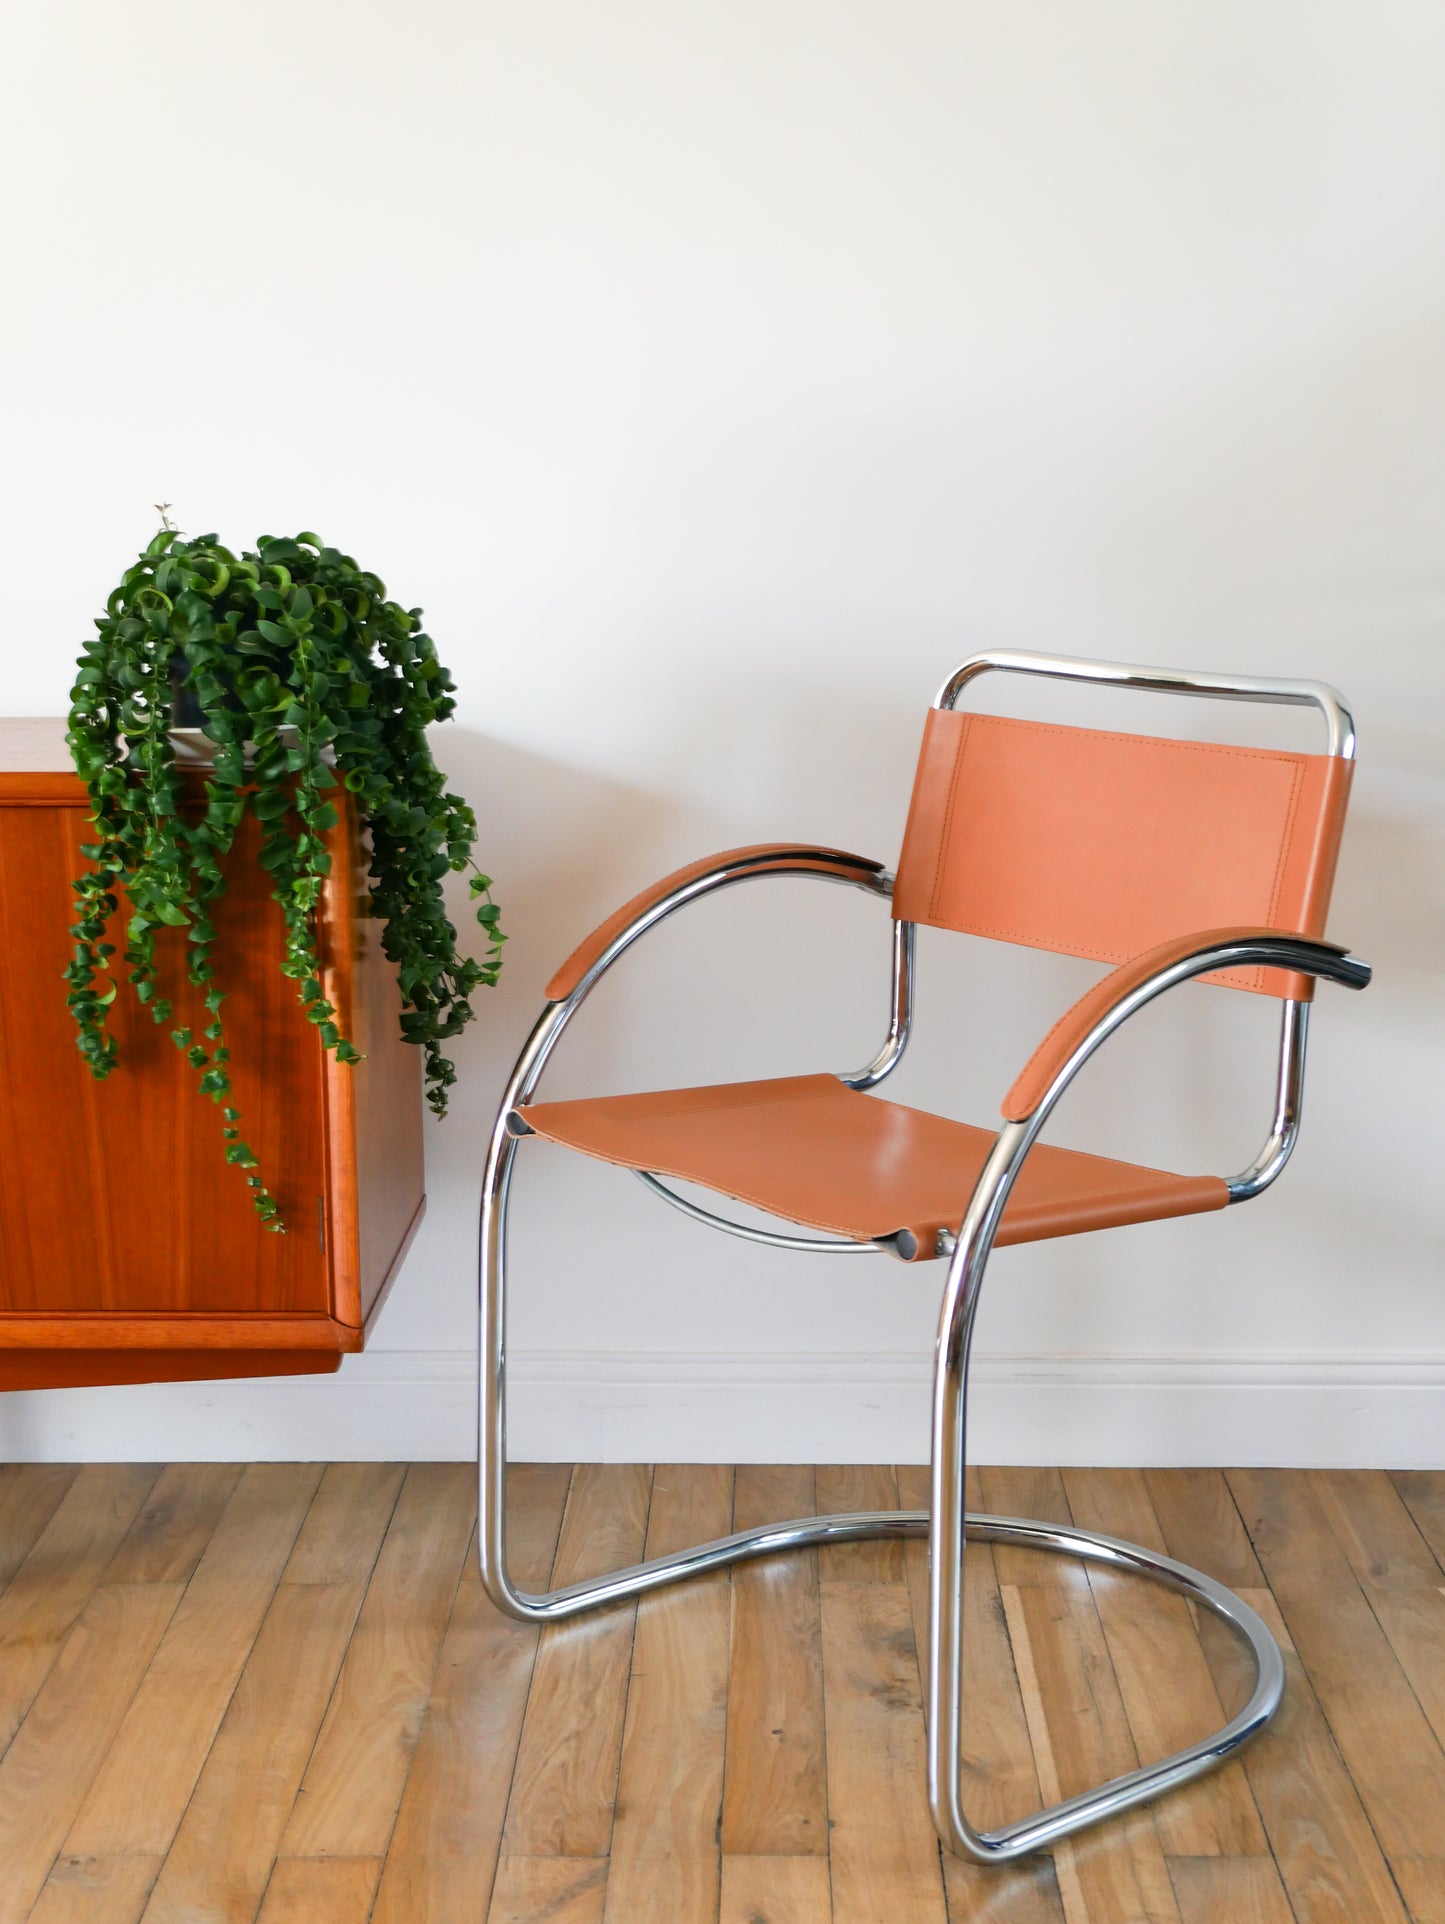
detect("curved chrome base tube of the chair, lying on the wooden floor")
[483,1510,1285,1864]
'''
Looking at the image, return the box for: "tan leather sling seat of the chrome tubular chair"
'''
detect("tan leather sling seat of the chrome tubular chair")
[516,1076,1230,1256]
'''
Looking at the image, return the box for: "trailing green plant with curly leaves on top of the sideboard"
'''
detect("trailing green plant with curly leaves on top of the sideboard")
[65,525,506,1229]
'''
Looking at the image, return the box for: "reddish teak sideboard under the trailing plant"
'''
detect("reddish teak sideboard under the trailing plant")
[0,722,425,1389]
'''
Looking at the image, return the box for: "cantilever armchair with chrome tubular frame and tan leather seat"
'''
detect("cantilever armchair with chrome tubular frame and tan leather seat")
[479,652,1370,1862]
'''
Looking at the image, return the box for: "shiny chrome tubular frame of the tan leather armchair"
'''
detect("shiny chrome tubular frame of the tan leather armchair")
[477,654,1370,1864]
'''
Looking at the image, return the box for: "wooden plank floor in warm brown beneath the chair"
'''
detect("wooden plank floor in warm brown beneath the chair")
[0,1464,1445,1924]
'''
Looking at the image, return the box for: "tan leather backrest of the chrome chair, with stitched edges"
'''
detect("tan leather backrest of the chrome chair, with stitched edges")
[893,708,1355,999]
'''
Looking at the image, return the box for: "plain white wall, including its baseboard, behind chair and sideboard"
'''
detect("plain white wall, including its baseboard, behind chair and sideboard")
[0,0,1445,1462]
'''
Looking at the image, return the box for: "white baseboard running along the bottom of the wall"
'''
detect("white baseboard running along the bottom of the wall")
[0,1351,1445,1468]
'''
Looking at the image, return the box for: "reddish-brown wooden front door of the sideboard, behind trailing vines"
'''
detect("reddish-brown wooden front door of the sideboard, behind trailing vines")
[0,783,331,1318]
